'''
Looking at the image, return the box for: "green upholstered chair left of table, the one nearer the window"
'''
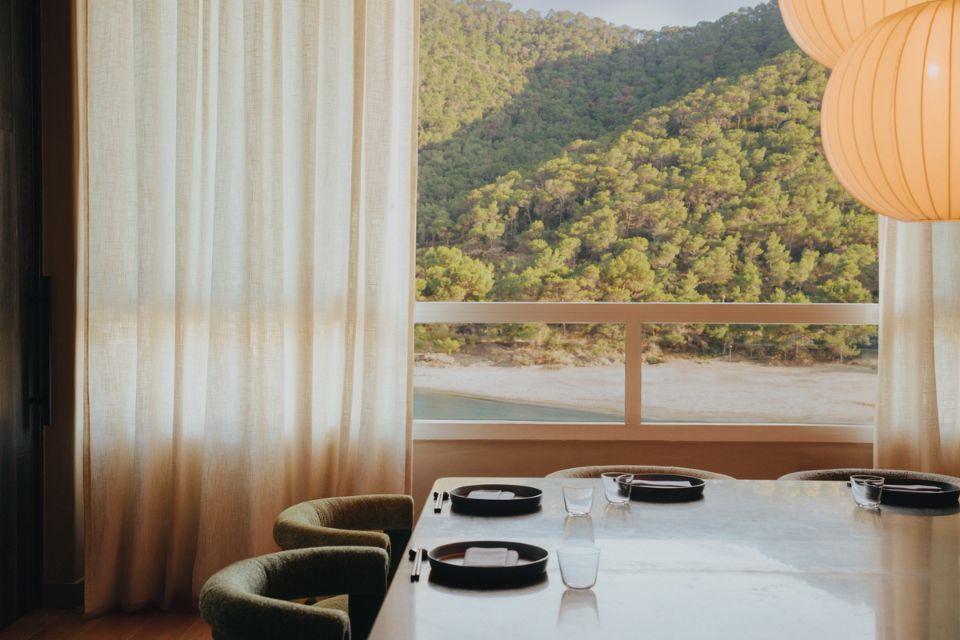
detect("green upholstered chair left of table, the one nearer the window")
[273,494,413,577]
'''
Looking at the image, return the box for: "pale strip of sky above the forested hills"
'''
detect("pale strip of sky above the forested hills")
[506,0,761,30]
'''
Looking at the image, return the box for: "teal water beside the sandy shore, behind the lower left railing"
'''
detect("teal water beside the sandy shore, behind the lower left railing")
[413,389,623,422]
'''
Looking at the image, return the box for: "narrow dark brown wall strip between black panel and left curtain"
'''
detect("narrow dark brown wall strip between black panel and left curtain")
[40,0,83,606]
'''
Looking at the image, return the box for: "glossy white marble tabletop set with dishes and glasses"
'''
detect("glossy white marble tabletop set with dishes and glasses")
[371,478,960,640]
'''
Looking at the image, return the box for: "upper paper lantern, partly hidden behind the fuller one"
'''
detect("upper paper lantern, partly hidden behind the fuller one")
[780,0,928,69]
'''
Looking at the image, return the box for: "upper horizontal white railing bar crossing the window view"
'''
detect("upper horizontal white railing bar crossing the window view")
[413,302,879,325]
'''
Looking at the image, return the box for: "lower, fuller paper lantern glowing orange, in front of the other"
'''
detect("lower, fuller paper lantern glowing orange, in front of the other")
[821,0,960,220]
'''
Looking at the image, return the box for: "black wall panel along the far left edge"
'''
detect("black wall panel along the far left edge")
[0,0,44,627]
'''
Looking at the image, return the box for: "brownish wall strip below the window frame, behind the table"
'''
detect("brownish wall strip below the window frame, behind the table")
[413,440,873,510]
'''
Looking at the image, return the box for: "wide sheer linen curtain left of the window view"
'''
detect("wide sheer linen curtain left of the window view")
[76,0,419,612]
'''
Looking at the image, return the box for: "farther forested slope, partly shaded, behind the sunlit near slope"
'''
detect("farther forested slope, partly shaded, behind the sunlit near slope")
[418,0,793,244]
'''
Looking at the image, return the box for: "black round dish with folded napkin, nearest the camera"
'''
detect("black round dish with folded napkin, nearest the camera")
[427,540,550,589]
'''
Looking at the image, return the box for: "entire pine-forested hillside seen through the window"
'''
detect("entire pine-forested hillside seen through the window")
[417,0,877,358]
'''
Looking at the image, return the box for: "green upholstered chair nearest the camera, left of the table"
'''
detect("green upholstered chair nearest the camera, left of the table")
[200,546,389,640]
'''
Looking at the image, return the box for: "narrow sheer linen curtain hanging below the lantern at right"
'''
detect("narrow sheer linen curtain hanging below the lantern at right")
[874,218,960,476]
